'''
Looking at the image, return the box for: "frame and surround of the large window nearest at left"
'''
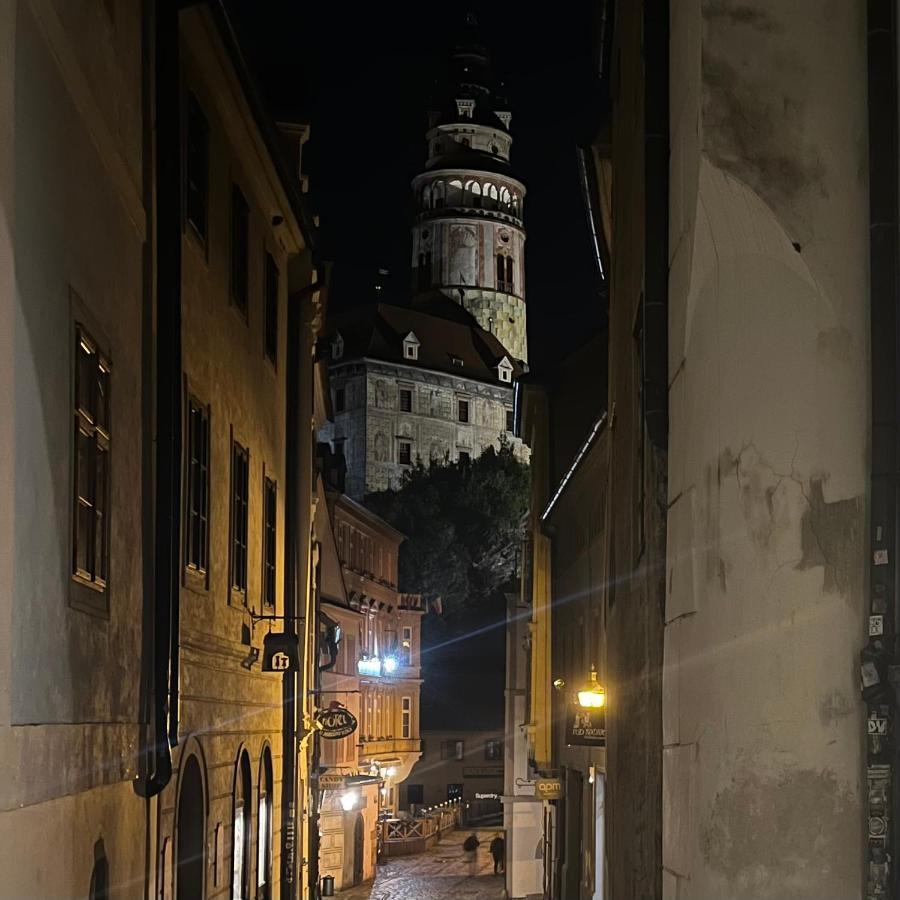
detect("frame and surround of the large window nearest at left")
[69,317,112,617]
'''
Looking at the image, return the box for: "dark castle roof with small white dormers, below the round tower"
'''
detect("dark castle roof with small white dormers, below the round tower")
[326,301,523,384]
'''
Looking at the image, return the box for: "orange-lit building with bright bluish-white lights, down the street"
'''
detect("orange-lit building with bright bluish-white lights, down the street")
[316,482,424,890]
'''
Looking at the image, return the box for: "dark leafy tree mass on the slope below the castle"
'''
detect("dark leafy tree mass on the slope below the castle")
[366,439,529,621]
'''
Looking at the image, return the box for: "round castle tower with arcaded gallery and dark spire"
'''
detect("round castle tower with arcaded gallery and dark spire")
[412,16,528,362]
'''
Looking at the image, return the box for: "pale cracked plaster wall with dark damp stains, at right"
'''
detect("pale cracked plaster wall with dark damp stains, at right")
[663,0,869,900]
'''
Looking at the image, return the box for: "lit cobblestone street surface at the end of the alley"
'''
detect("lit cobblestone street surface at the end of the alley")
[335,829,505,900]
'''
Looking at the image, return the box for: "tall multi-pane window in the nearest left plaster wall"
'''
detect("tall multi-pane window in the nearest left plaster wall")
[72,325,111,591]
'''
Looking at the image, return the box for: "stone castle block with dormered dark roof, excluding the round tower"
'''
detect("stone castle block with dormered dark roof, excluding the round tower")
[322,304,526,500]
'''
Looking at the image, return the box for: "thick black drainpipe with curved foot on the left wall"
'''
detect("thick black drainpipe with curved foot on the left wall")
[135,2,182,797]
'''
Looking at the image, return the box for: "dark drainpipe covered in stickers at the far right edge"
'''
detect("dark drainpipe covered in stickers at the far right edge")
[860,0,900,900]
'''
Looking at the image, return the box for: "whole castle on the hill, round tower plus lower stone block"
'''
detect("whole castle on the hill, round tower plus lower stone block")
[323,29,528,499]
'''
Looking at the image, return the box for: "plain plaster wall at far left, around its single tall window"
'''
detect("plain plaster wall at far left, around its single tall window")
[0,0,148,898]
